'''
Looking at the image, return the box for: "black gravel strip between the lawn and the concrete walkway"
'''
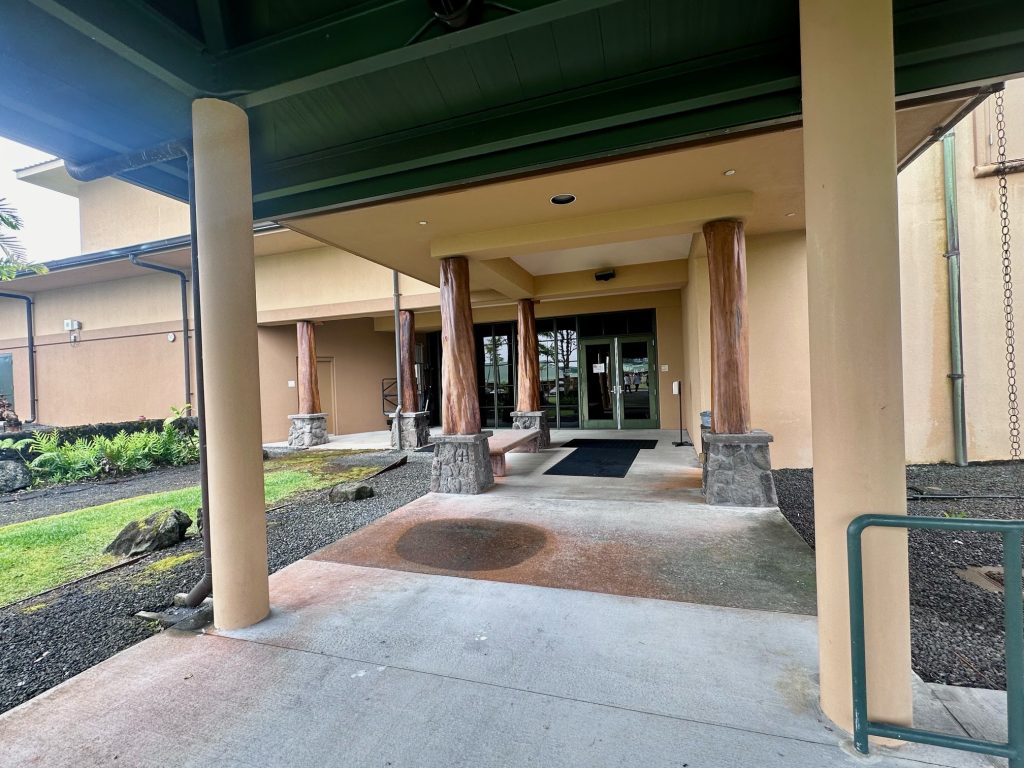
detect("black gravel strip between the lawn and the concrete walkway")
[0,452,432,712]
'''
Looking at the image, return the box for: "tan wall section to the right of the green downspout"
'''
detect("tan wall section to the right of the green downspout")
[956,102,1024,462]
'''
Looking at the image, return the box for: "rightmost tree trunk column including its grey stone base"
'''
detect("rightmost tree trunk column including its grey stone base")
[700,219,778,507]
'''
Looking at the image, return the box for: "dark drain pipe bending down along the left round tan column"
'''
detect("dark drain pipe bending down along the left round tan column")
[65,139,213,608]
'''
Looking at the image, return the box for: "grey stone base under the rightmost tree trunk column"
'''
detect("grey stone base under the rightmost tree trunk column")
[701,429,778,507]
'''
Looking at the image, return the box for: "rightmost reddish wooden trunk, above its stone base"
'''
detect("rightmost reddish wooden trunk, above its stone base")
[703,220,751,434]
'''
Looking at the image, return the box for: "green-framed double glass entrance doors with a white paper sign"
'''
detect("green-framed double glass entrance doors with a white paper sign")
[580,336,657,429]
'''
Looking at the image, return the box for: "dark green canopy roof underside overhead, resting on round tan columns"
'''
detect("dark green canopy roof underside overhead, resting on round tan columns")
[0,0,1024,218]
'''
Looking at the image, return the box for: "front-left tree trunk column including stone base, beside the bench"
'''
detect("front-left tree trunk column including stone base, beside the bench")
[430,256,495,494]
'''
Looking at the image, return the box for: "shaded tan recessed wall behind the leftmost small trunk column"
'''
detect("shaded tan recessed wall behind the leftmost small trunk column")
[259,318,394,441]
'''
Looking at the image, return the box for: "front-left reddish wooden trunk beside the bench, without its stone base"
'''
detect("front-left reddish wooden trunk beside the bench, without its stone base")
[440,256,480,434]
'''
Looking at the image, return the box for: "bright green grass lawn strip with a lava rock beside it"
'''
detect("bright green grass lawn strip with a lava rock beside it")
[0,466,377,605]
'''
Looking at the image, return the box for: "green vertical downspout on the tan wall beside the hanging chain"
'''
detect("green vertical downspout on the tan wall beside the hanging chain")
[942,131,968,467]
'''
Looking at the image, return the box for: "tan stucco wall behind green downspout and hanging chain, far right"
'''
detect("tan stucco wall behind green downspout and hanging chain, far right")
[899,81,1024,463]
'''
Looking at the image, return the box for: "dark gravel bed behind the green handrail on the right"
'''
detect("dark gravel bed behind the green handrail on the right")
[772,462,1024,690]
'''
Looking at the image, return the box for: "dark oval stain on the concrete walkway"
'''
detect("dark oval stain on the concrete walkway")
[394,517,548,570]
